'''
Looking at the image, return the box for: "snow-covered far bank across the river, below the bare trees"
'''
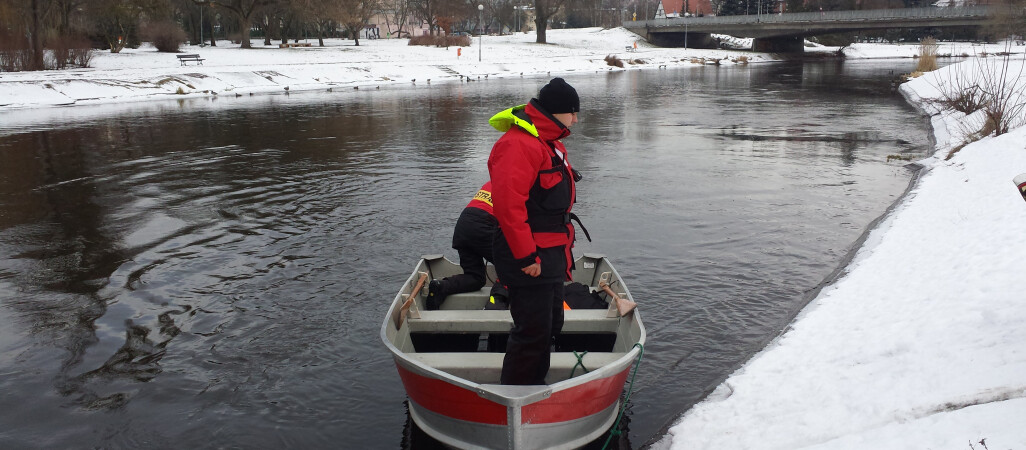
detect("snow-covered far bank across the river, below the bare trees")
[0,28,1013,112]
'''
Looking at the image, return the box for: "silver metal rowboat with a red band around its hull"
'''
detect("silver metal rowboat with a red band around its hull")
[382,255,645,449]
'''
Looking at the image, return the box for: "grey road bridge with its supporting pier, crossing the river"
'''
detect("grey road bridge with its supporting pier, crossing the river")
[624,5,991,52]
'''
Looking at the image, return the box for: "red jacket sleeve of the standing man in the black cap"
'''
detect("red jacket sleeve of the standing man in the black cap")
[488,129,545,259]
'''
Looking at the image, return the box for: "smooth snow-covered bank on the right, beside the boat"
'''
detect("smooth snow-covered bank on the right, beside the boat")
[655,56,1026,449]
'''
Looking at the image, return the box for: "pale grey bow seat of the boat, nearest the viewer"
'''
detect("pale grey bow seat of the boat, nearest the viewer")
[406,352,626,384]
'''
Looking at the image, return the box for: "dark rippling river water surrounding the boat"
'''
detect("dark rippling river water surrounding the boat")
[0,60,931,449]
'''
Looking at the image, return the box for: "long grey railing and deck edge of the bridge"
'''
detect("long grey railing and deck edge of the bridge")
[624,5,990,28]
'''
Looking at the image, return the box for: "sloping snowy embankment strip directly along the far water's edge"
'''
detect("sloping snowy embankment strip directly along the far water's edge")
[0,40,923,113]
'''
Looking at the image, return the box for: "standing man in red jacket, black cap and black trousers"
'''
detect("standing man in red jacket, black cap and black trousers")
[488,78,581,384]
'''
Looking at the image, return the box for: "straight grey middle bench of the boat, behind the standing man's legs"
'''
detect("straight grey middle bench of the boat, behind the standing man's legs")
[406,310,620,334]
